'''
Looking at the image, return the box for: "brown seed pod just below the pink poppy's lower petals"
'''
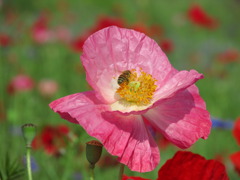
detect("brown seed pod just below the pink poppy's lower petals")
[86,140,103,169]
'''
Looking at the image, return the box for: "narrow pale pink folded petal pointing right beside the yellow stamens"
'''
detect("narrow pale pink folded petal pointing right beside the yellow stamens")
[154,70,203,100]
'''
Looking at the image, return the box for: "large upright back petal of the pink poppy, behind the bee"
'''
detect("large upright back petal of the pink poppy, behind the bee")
[81,26,172,103]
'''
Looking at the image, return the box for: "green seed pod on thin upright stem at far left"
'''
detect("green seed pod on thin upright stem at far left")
[22,124,36,148]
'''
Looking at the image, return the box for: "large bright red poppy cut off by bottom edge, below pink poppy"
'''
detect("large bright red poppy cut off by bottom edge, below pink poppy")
[157,151,228,180]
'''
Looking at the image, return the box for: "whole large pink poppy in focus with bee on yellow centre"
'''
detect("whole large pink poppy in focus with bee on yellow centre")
[50,26,211,172]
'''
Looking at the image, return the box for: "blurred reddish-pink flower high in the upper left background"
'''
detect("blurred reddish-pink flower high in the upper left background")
[32,15,53,44]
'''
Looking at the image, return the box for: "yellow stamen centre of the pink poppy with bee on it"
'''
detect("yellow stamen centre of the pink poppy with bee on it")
[116,69,157,106]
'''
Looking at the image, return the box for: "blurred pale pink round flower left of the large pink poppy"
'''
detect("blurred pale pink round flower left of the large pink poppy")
[38,79,58,97]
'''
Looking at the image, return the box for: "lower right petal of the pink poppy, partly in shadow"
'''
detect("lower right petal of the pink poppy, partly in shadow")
[144,85,211,148]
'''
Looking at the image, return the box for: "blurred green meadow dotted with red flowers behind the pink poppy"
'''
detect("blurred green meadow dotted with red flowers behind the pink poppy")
[0,0,240,180]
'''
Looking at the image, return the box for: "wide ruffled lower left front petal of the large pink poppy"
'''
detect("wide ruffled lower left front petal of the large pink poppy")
[50,91,160,172]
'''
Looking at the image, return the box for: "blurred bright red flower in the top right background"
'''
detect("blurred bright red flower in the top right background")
[188,4,218,29]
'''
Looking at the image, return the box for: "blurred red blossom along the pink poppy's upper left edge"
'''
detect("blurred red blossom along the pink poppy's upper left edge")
[71,16,124,52]
